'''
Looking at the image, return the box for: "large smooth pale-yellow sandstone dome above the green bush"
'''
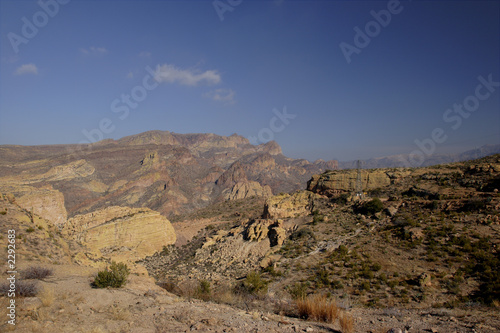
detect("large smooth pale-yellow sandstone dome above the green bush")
[63,206,176,260]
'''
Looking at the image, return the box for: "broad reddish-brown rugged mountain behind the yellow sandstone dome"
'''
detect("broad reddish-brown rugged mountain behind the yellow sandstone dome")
[0,131,337,218]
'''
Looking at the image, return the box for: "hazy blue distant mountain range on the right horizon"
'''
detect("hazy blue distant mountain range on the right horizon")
[338,144,500,169]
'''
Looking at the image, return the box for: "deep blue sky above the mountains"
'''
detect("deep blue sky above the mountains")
[0,0,500,160]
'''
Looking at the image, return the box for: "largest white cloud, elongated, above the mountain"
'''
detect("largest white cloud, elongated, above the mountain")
[155,64,221,86]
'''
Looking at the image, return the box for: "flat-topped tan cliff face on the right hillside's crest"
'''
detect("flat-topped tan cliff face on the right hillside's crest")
[307,169,395,195]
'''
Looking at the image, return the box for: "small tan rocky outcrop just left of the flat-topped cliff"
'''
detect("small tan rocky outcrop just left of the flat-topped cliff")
[263,191,320,219]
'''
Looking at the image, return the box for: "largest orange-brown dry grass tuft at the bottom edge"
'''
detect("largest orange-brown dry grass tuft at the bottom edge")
[295,295,339,323]
